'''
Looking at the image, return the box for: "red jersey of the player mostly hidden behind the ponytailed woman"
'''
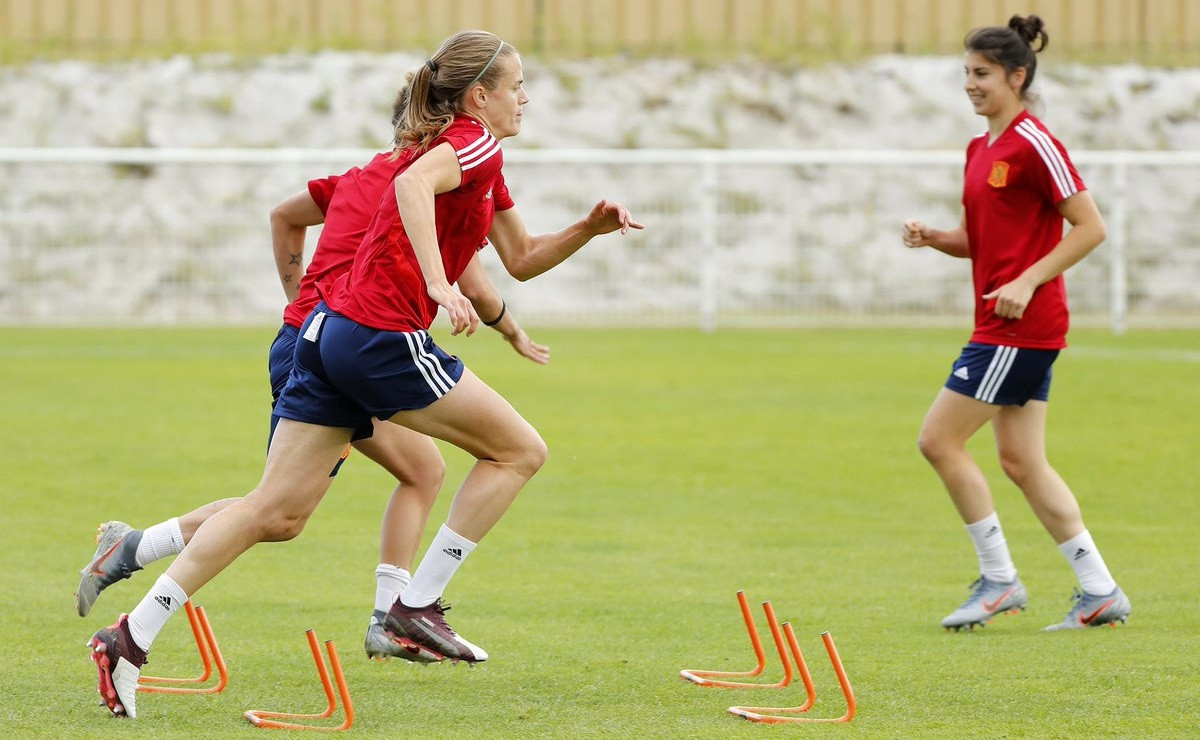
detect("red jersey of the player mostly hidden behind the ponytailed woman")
[283,154,402,329]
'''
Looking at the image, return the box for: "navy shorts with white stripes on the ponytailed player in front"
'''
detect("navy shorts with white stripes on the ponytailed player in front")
[275,302,463,439]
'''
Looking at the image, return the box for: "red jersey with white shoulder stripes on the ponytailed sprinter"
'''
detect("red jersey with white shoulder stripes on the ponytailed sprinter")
[319,115,512,331]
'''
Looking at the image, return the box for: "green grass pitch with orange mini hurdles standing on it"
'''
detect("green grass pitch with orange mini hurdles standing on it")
[0,327,1200,739]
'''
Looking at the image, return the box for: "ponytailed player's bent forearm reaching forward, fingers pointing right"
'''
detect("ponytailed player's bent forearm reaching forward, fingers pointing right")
[488,200,644,281]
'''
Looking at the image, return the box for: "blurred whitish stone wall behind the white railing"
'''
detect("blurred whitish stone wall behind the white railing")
[0,53,1200,323]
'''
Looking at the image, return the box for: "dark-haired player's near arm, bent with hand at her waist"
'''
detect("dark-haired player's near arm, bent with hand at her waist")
[983,191,1106,319]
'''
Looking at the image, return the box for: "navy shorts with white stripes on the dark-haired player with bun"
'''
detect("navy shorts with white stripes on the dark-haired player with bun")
[946,342,1058,405]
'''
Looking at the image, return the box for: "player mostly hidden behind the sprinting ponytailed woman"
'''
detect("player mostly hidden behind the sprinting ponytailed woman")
[76,145,550,662]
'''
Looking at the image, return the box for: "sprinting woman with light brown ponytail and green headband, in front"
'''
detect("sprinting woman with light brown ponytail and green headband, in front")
[90,31,642,716]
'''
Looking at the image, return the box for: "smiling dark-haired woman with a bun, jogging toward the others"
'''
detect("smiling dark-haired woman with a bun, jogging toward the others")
[904,16,1130,630]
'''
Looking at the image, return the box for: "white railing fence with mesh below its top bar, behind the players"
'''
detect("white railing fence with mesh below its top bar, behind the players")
[0,148,1200,331]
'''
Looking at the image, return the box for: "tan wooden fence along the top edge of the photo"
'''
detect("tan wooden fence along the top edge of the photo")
[0,0,1200,64]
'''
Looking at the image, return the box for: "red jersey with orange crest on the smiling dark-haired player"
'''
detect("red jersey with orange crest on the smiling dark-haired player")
[962,110,1086,349]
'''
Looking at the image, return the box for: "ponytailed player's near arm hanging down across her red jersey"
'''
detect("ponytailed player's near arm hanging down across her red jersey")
[396,143,479,336]
